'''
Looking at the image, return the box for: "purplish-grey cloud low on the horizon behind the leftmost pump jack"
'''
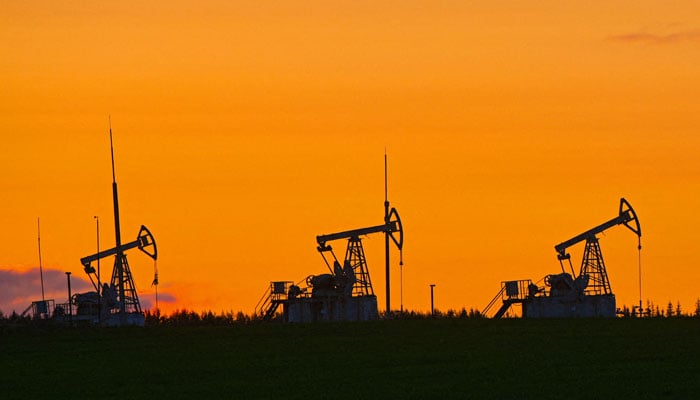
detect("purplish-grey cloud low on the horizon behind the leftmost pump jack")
[0,268,94,315]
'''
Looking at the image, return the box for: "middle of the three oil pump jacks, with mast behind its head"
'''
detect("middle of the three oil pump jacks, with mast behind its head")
[256,156,403,322]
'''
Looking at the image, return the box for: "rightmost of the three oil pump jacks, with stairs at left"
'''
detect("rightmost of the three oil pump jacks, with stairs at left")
[483,198,642,318]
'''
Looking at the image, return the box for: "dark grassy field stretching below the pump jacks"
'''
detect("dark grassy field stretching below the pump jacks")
[0,318,700,399]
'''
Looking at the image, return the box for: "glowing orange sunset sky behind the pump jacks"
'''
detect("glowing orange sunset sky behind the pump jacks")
[0,1,700,318]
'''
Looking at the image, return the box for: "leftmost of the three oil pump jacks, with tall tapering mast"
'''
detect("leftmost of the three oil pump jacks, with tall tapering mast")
[72,123,158,326]
